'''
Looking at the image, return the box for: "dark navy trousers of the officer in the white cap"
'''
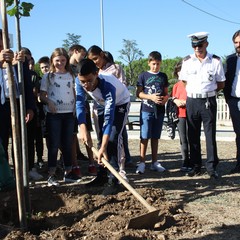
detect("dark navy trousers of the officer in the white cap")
[186,96,218,174]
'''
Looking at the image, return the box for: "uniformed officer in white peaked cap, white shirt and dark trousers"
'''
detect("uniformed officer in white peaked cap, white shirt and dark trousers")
[179,32,225,179]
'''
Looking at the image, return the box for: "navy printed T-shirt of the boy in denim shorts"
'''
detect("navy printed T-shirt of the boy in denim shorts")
[137,72,168,112]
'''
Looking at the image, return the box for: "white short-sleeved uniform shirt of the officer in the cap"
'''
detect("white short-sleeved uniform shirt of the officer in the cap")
[179,53,225,94]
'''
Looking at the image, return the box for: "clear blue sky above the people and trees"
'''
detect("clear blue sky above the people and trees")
[2,0,240,61]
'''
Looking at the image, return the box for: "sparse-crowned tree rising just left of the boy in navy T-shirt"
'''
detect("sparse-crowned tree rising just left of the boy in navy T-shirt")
[119,39,143,86]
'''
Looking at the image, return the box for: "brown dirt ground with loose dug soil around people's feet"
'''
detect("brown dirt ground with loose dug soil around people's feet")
[0,139,240,240]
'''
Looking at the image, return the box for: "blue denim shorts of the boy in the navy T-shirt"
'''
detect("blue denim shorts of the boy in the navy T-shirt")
[140,112,164,139]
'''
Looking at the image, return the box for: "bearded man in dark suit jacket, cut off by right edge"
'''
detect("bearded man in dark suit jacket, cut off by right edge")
[224,30,240,173]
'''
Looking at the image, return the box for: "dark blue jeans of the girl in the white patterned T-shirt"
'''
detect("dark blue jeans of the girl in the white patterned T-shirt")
[47,113,75,174]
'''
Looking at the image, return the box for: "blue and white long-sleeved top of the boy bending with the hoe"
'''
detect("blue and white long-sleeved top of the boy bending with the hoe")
[76,74,130,135]
